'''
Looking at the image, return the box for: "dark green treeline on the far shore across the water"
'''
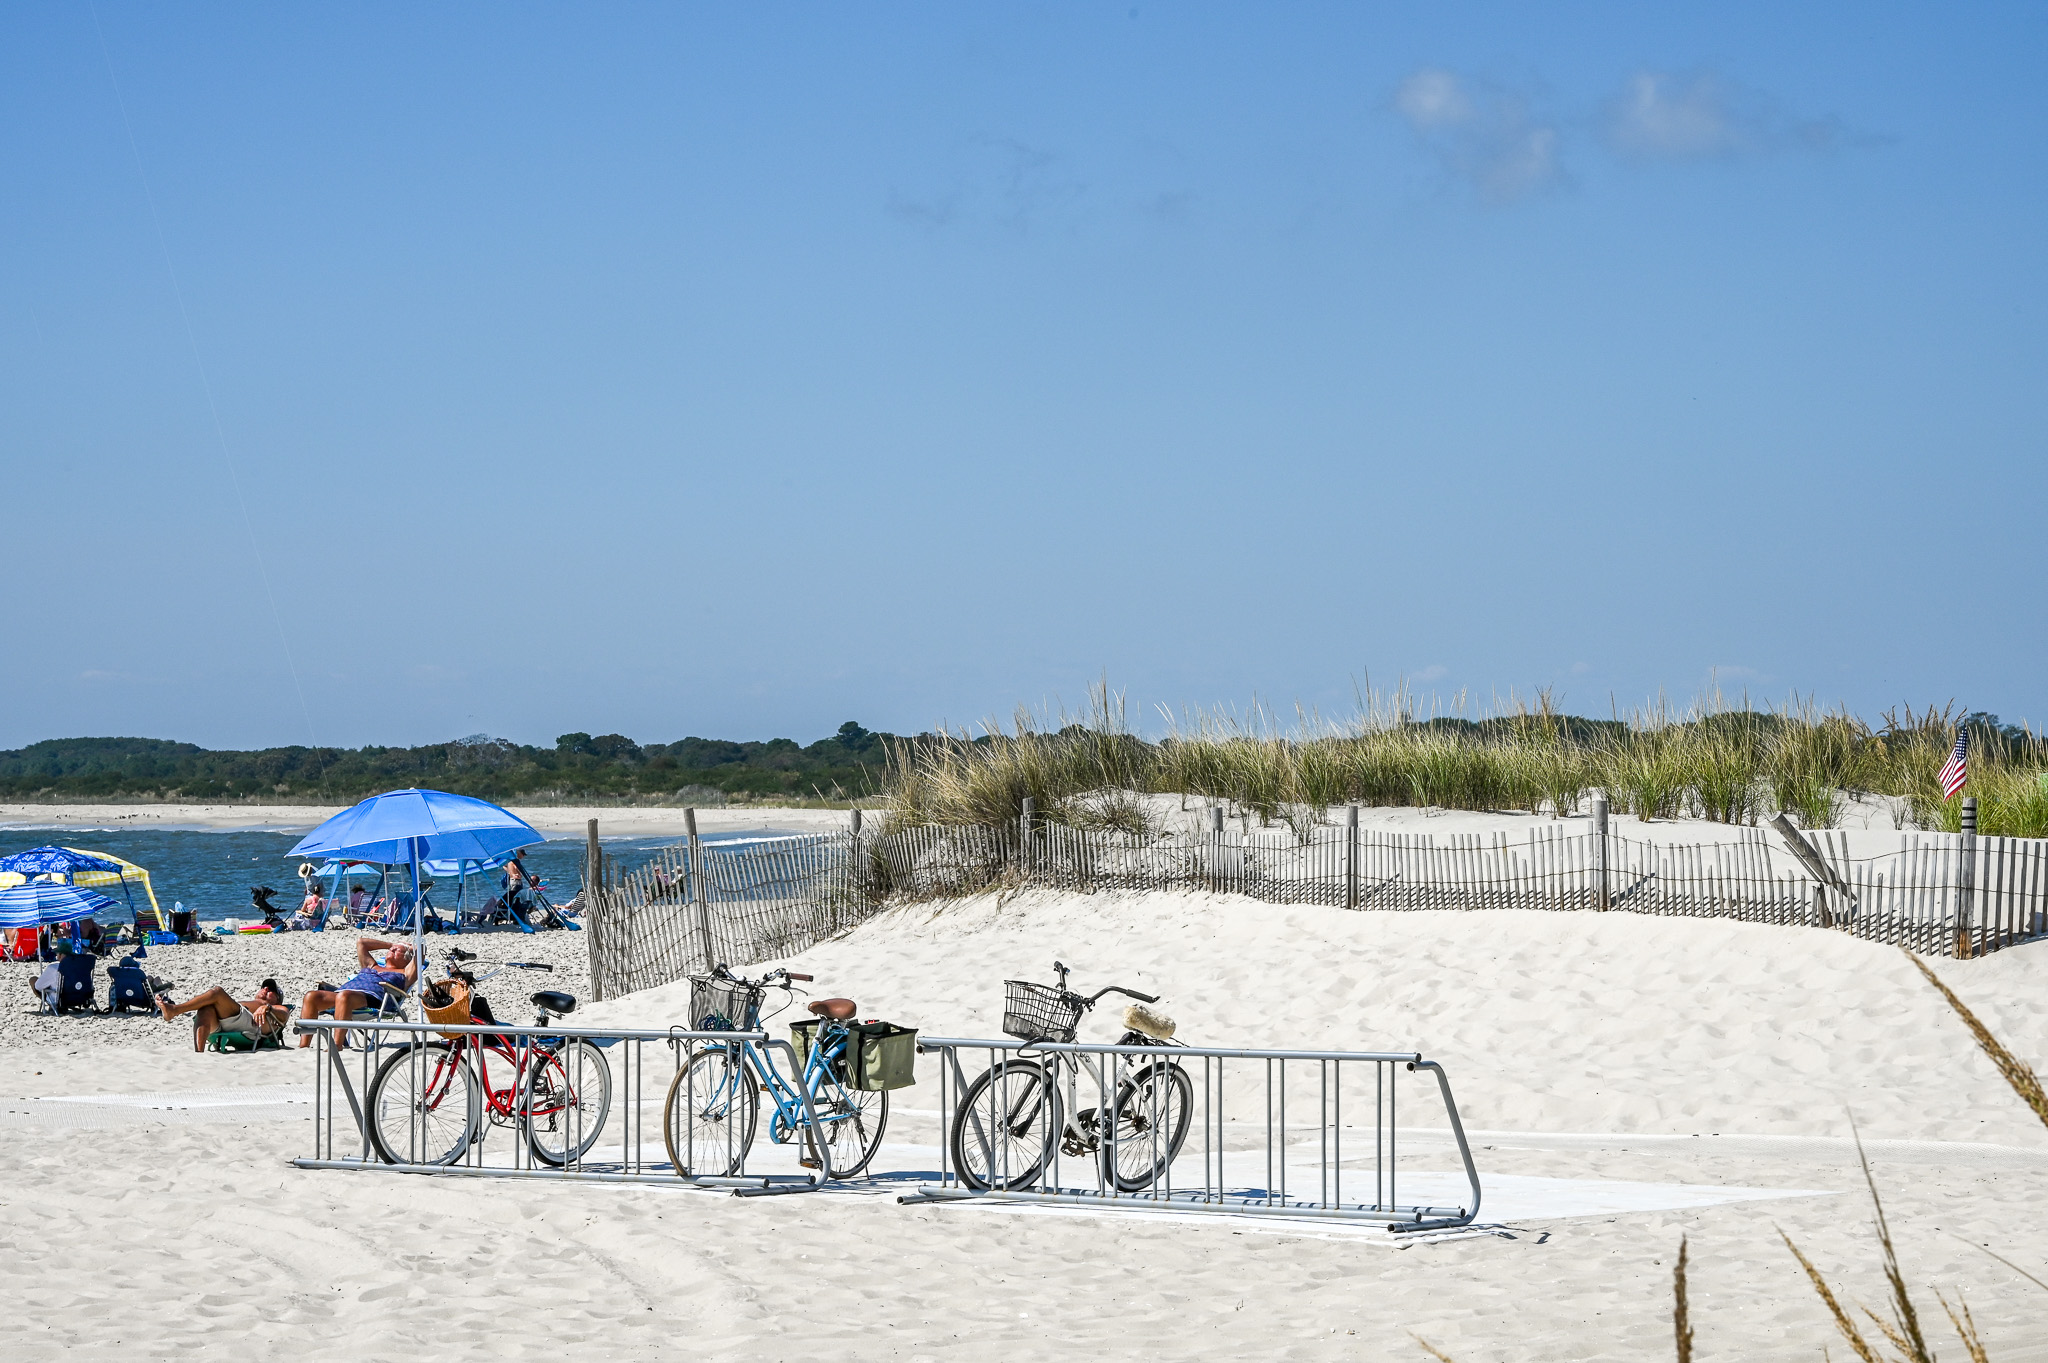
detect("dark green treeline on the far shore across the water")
[0,722,895,804]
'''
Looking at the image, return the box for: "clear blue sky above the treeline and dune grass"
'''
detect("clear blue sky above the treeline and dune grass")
[0,0,2048,747]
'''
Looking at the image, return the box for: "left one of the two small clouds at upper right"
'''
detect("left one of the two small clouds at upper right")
[1395,68,1565,203]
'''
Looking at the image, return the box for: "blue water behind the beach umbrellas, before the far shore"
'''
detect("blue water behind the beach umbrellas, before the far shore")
[0,827,768,923]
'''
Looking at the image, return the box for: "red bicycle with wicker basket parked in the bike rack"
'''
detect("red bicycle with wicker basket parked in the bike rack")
[367,948,612,1167]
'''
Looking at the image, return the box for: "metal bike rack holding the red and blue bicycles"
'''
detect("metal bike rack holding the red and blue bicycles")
[293,1017,825,1197]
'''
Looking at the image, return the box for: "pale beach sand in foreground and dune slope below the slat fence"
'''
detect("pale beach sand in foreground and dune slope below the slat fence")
[0,894,2048,1363]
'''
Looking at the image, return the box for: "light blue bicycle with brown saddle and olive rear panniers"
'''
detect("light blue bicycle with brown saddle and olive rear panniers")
[662,966,889,1179]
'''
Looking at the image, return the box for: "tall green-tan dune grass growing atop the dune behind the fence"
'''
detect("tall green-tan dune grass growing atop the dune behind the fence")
[889,686,2048,837]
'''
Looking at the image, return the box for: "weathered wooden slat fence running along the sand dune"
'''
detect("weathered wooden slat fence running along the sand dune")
[586,821,2048,999]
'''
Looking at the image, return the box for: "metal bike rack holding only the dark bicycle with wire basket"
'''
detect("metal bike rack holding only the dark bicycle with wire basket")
[901,1038,1481,1232]
